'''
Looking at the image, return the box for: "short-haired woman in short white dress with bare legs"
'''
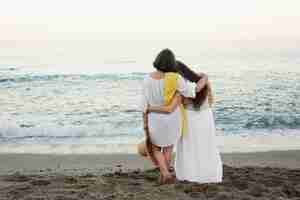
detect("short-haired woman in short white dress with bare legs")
[142,49,209,183]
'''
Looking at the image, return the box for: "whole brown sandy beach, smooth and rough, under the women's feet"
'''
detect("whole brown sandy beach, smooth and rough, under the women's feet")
[0,150,300,200]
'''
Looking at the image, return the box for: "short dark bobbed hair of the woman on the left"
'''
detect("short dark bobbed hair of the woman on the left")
[153,49,177,72]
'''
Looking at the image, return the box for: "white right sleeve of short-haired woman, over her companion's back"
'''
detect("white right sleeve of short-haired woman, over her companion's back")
[177,75,197,98]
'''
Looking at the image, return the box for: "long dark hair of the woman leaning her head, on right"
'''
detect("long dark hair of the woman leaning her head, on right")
[176,61,208,109]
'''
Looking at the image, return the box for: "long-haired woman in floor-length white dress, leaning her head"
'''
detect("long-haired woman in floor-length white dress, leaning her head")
[148,61,223,183]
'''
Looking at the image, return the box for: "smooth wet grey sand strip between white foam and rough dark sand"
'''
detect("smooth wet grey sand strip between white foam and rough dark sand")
[0,150,300,174]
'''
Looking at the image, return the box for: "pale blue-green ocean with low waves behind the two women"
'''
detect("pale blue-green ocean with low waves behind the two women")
[0,51,300,154]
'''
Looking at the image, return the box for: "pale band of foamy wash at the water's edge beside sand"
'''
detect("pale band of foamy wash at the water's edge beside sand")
[0,132,300,155]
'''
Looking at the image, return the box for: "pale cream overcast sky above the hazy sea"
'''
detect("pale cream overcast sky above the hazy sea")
[0,0,300,40]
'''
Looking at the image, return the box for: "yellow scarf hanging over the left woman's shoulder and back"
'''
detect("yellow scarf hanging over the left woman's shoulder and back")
[164,72,187,135]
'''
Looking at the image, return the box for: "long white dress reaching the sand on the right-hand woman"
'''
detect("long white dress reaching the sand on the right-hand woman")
[175,100,223,183]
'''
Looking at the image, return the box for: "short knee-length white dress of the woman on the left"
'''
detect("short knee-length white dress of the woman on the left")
[141,75,196,147]
